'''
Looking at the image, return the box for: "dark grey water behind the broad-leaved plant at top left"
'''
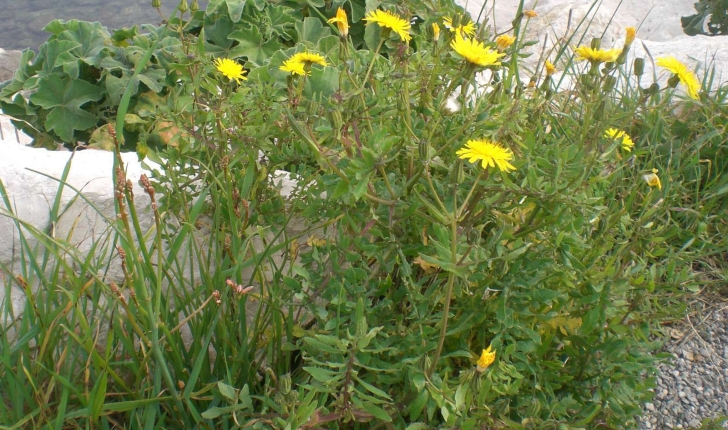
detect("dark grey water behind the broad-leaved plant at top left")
[0,0,207,51]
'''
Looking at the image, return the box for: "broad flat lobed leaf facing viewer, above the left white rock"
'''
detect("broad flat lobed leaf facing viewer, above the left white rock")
[30,75,102,142]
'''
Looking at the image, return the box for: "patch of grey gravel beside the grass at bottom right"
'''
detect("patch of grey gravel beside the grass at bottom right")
[640,305,728,430]
